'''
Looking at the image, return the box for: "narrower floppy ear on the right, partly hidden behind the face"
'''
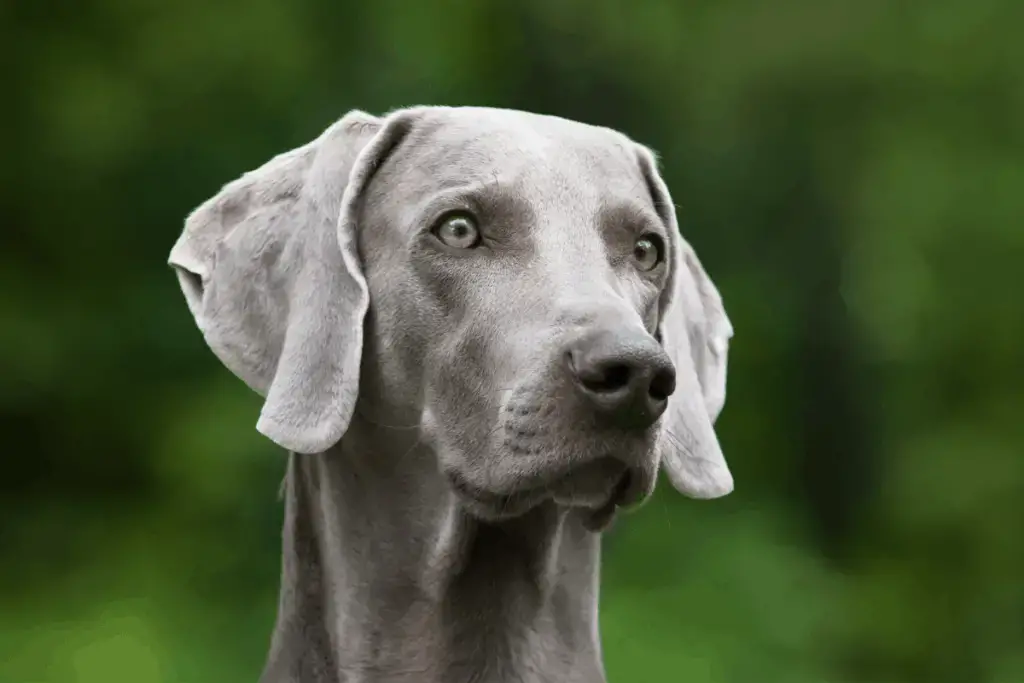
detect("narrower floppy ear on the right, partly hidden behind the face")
[639,145,733,499]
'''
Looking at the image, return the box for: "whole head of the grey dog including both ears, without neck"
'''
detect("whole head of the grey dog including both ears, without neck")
[172,108,732,526]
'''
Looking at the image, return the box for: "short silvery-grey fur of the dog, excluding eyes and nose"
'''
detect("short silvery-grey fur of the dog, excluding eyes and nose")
[170,106,733,683]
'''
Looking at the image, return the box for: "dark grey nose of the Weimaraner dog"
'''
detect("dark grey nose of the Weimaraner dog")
[566,329,676,429]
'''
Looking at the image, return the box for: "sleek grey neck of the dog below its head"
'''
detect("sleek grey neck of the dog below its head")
[261,417,605,683]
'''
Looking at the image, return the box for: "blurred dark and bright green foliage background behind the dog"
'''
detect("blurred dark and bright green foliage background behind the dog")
[0,0,1024,683]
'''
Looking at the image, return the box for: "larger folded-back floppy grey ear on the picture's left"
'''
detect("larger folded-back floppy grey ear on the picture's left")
[169,111,415,453]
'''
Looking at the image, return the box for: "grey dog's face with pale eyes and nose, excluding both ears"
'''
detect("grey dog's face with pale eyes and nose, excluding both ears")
[359,110,675,517]
